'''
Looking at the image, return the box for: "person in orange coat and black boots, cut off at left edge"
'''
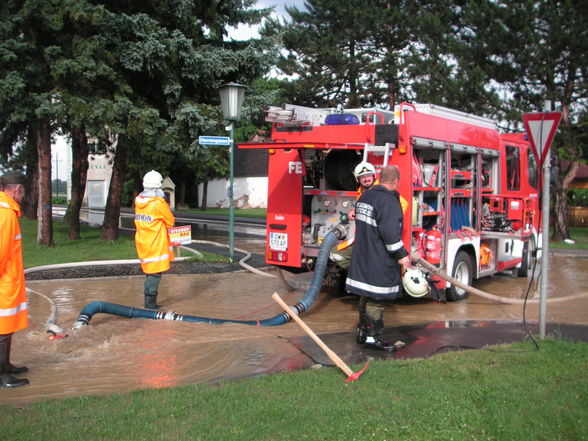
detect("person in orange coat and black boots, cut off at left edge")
[0,172,29,387]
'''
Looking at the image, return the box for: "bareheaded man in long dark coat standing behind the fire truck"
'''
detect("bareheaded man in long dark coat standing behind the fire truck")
[345,165,410,351]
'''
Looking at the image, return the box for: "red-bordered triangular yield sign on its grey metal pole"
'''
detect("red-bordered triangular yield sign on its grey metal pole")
[523,108,561,339]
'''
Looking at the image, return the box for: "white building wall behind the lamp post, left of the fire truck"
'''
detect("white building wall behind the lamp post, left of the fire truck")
[198,177,267,208]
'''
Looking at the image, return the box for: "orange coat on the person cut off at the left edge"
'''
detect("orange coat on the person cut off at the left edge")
[0,191,29,334]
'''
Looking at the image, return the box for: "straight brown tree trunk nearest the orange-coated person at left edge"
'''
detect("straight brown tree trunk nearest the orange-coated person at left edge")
[37,118,53,247]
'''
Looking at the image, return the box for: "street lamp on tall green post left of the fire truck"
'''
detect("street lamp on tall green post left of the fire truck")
[219,83,246,262]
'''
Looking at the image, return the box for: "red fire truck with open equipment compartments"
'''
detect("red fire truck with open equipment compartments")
[239,103,540,300]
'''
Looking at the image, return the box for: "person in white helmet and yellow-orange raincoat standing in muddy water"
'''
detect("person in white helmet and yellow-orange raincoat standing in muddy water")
[135,170,175,309]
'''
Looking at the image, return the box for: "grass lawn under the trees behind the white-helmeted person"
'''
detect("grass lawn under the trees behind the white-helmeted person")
[20,218,228,268]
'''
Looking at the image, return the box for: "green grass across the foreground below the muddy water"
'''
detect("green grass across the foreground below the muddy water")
[0,340,588,441]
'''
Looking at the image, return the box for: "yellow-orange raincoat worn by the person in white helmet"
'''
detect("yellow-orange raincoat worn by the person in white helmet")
[135,191,175,274]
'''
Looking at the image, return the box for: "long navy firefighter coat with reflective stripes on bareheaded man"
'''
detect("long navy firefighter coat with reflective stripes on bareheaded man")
[345,185,408,300]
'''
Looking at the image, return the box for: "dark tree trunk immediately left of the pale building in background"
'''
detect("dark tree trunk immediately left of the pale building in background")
[65,127,88,240]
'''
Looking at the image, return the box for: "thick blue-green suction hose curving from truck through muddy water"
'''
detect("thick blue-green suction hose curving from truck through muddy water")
[73,224,346,330]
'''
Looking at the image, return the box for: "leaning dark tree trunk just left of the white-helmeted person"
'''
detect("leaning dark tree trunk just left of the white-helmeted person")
[101,135,127,242]
